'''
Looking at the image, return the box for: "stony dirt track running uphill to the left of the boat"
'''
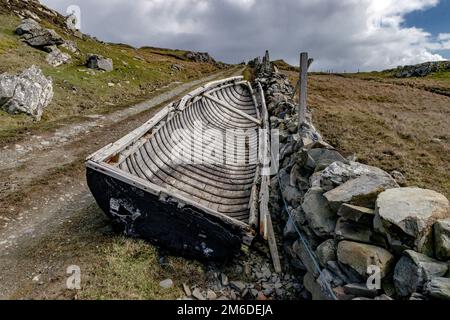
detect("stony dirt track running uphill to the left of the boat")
[0,71,240,299]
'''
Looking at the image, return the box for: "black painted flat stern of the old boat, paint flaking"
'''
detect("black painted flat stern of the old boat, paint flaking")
[87,168,242,261]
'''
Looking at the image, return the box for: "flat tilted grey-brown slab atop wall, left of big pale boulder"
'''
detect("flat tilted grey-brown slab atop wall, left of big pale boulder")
[324,174,398,212]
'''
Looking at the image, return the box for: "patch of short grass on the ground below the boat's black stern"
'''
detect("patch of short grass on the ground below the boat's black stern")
[79,237,205,300]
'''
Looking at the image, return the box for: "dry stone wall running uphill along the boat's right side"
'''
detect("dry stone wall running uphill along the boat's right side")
[251,57,450,300]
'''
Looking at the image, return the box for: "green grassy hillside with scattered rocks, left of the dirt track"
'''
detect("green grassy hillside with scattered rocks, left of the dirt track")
[0,13,223,143]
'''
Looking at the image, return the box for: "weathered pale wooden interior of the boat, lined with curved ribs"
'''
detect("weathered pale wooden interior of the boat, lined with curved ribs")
[95,79,261,227]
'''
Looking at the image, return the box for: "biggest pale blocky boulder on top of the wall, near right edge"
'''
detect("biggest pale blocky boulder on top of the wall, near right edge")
[374,188,450,256]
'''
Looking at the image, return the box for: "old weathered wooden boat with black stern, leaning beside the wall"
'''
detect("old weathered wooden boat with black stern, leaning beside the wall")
[86,77,269,260]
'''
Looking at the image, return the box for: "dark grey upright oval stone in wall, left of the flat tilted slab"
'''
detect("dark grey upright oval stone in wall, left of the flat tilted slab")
[302,188,337,237]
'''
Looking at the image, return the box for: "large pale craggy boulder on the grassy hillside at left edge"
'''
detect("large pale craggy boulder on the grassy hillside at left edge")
[0,66,53,121]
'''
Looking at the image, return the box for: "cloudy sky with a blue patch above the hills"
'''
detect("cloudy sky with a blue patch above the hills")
[41,0,450,71]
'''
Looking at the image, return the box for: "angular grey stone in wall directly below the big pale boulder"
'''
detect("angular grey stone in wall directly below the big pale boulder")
[394,250,448,297]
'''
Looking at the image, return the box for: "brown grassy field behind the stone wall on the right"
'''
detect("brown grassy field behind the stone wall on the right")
[285,71,450,198]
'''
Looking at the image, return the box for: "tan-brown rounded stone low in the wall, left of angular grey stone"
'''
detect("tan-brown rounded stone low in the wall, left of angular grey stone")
[337,241,395,278]
